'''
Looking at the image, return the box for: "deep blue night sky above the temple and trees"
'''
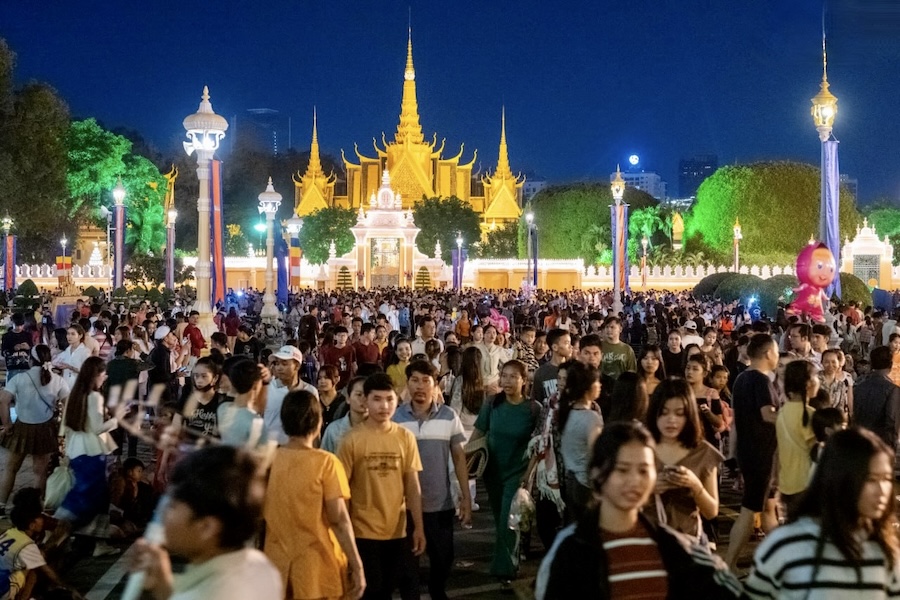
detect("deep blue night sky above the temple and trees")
[0,0,900,202]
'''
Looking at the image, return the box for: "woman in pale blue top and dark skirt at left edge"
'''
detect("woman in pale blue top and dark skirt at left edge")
[0,344,69,505]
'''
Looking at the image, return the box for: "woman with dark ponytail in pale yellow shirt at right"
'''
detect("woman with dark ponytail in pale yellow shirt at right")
[775,360,819,518]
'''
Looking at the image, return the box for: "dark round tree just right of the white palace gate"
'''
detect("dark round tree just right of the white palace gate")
[413,196,481,263]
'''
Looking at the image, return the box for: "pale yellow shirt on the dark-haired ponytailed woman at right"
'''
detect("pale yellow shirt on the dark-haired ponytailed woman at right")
[775,402,816,494]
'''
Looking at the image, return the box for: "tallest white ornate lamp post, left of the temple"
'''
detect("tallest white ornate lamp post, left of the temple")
[183,86,228,339]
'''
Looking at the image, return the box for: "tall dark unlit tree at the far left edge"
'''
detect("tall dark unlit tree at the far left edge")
[0,40,71,262]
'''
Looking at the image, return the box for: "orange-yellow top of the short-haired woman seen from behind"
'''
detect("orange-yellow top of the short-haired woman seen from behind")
[263,448,350,598]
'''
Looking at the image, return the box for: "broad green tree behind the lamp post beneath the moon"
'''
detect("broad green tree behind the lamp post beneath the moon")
[520,183,657,264]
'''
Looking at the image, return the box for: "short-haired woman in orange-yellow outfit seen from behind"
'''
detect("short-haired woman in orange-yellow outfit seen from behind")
[263,390,366,598]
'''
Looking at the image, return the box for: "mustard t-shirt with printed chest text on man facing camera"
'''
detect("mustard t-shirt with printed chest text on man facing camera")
[337,422,422,540]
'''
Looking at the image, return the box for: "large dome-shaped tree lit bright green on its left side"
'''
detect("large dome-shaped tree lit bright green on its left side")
[685,162,860,262]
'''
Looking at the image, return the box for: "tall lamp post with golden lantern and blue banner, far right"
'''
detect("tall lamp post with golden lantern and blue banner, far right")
[810,36,841,297]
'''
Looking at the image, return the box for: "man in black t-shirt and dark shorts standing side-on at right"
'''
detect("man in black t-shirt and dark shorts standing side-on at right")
[725,334,778,571]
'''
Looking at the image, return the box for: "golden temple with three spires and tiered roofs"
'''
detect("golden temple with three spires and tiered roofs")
[294,29,525,231]
